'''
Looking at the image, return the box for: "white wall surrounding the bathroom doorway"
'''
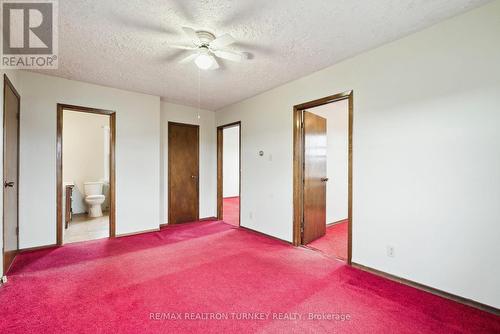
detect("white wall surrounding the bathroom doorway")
[19,72,160,248]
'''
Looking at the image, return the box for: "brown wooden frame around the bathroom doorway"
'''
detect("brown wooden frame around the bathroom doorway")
[56,103,116,246]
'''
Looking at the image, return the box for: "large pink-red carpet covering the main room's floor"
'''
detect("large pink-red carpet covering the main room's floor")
[0,221,500,334]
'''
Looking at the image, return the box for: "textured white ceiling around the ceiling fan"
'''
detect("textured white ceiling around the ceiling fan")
[33,0,489,110]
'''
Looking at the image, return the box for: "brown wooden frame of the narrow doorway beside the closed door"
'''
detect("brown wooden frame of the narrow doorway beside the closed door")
[217,121,241,226]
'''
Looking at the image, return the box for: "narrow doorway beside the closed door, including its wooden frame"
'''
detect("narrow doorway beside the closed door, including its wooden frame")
[217,122,241,226]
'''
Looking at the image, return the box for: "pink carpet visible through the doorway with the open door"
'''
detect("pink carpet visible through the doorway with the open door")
[307,220,347,260]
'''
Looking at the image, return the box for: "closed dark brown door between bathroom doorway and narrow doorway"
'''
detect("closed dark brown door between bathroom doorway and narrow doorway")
[168,122,199,224]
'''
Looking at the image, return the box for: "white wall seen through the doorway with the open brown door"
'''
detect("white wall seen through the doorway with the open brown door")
[308,100,349,224]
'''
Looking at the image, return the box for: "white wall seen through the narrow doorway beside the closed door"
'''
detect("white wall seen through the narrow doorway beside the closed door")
[222,126,240,197]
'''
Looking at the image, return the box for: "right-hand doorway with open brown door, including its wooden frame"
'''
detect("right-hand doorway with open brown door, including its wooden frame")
[293,91,353,264]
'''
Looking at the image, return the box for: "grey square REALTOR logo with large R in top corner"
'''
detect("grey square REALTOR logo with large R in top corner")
[0,0,58,69]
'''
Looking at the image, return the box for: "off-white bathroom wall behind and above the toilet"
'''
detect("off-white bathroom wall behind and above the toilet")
[63,110,110,213]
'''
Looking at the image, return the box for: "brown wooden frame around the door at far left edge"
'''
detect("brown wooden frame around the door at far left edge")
[2,73,21,275]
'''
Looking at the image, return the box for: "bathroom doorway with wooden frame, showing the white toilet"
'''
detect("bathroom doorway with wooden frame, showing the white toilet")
[57,104,116,245]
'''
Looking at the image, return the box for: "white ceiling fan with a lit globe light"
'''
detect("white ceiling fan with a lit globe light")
[168,27,246,70]
